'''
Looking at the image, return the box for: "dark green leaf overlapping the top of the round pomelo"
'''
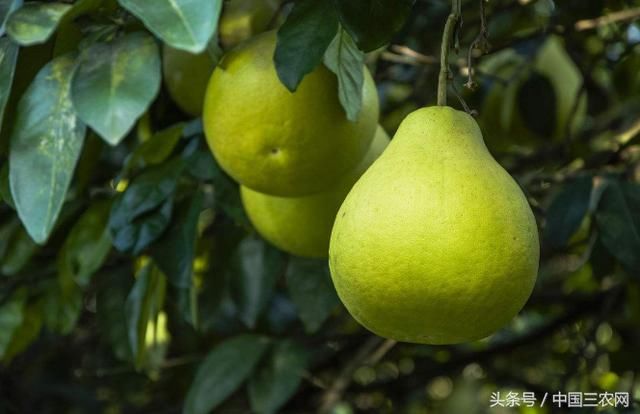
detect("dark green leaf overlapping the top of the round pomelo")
[274,0,338,92]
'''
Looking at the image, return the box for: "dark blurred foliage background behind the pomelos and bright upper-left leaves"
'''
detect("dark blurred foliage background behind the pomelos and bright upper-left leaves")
[0,0,640,414]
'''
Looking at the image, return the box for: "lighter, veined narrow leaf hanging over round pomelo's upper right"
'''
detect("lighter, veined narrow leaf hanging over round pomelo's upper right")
[324,29,364,122]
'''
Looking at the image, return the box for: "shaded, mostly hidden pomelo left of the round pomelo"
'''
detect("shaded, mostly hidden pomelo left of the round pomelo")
[162,45,215,116]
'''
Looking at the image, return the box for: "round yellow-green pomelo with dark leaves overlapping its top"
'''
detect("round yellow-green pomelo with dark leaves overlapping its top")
[203,32,378,196]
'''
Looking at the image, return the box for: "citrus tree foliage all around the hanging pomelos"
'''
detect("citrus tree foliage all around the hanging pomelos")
[0,0,640,414]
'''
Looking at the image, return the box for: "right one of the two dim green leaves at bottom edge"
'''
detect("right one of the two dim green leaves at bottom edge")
[249,340,309,414]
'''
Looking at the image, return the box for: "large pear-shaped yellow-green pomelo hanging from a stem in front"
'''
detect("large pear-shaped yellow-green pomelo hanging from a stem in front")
[329,107,540,344]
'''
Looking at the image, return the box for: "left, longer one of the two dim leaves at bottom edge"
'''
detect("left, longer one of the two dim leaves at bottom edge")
[183,335,269,414]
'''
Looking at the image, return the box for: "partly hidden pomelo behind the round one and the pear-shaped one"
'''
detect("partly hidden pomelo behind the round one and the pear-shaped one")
[240,127,389,258]
